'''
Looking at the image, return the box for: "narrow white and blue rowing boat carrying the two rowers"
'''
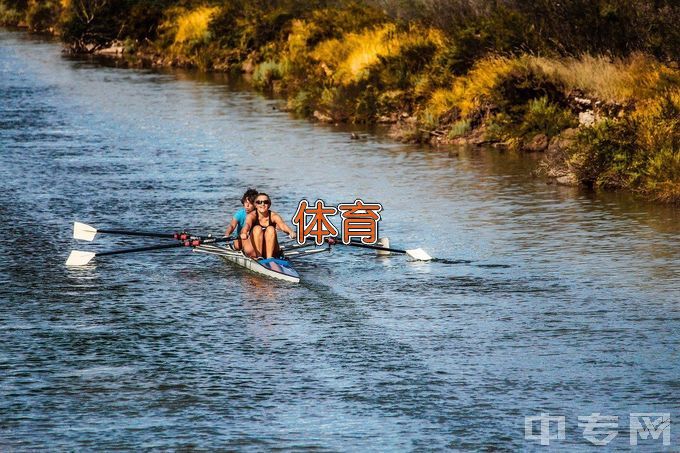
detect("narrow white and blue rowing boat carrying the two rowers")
[194,240,329,283]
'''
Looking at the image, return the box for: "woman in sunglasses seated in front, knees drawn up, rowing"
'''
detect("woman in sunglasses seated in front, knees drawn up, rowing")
[240,193,295,258]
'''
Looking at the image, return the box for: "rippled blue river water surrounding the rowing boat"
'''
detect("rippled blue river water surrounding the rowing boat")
[0,31,680,451]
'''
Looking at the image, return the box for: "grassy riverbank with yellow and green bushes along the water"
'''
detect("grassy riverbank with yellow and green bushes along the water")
[5,0,680,202]
